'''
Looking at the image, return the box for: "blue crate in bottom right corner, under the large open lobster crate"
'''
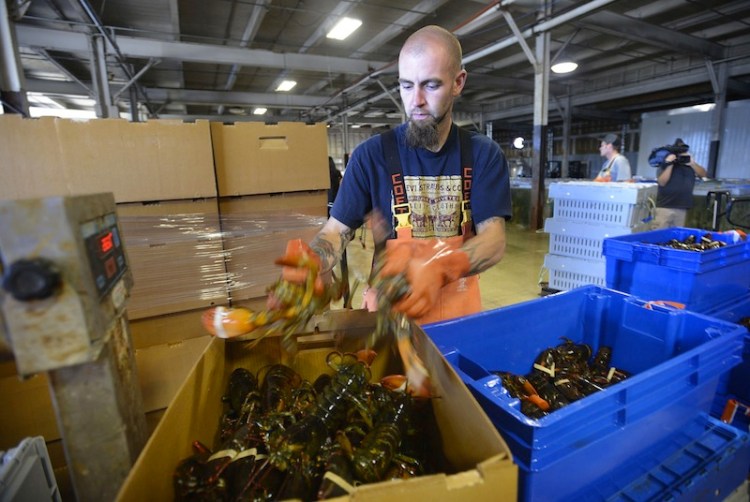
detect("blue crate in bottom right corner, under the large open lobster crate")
[569,415,750,502]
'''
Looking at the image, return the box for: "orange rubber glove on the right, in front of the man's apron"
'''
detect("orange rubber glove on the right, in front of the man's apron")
[380,239,471,319]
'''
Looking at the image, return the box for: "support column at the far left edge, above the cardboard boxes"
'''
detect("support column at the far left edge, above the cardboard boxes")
[0,2,29,117]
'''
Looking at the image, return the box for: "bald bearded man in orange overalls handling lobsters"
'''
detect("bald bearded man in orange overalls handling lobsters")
[286,26,512,323]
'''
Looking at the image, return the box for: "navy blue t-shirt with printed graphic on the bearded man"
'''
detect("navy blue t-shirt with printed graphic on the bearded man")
[331,124,512,238]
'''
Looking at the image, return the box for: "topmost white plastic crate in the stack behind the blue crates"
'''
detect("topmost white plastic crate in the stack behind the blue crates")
[549,181,657,227]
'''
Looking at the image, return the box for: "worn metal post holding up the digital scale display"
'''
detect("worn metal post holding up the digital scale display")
[48,317,148,501]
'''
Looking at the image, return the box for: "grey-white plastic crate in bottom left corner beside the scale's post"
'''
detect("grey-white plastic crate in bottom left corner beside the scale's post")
[0,436,62,502]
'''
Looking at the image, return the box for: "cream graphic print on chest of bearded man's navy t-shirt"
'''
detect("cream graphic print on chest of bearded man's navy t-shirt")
[404,176,461,238]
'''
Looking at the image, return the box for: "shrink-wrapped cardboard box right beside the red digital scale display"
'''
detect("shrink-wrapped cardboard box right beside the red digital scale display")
[117,199,228,319]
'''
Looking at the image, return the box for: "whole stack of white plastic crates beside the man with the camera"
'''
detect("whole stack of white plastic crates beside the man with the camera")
[544,181,657,291]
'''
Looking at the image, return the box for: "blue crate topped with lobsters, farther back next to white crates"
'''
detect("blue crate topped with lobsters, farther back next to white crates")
[604,228,750,312]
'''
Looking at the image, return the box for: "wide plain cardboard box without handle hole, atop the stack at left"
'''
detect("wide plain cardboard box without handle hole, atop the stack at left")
[0,115,216,202]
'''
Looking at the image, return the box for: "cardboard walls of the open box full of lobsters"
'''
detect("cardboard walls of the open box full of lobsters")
[118,310,518,502]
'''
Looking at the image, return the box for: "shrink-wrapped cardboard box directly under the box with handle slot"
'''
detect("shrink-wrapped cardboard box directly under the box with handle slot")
[219,190,328,302]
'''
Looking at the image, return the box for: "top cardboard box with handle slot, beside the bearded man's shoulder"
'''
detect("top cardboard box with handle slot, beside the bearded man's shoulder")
[211,122,330,196]
